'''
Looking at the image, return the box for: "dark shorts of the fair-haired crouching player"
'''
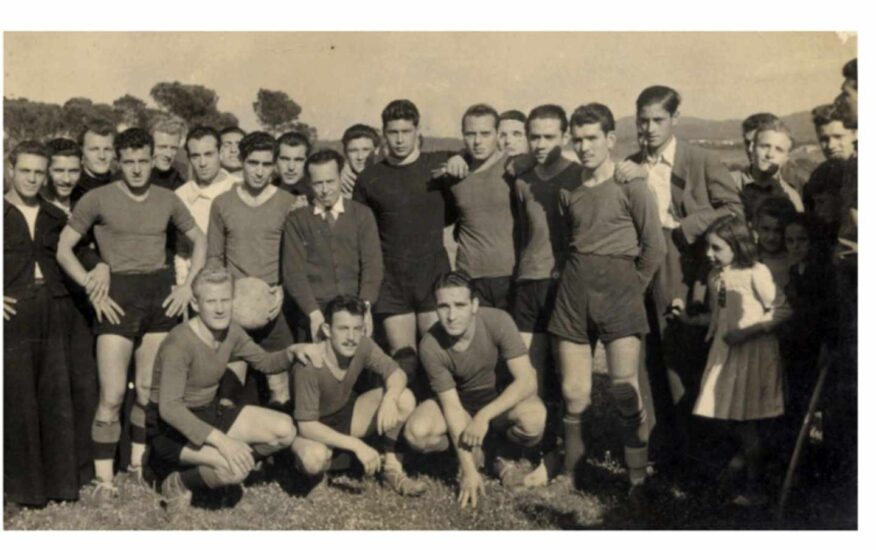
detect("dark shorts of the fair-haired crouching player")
[146,399,242,482]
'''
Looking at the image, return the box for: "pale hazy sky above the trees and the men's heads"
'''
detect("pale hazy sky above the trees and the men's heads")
[4,32,857,139]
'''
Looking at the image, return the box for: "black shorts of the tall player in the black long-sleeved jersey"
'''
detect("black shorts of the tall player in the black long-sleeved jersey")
[374,252,450,317]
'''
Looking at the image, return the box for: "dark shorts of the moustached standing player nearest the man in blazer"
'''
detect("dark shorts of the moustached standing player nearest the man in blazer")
[548,254,648,344]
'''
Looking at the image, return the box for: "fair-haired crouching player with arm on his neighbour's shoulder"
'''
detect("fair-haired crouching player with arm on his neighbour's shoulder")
[144,267,318,513]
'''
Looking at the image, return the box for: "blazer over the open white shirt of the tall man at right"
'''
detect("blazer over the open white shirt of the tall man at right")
[629,137,743,244]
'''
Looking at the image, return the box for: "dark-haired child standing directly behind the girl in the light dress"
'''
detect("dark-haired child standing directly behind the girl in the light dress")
[751,197,795,289]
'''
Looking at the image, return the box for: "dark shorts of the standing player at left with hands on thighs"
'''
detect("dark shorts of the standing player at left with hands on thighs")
[94,268,180,340]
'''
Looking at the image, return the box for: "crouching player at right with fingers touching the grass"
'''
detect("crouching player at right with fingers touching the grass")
[405,272,547,508]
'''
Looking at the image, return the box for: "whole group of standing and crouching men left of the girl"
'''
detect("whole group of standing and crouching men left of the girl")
[4,58,856,520]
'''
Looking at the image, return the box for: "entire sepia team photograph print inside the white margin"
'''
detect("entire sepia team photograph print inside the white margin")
[2,7,866,544]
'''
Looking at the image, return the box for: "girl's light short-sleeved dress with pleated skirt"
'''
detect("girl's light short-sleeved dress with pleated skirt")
[693,263,784,420]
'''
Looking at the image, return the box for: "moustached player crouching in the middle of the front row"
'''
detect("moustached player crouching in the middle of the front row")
[292,295,426,496]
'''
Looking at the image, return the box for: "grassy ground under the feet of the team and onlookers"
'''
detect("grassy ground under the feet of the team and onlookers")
[3,364,857,530]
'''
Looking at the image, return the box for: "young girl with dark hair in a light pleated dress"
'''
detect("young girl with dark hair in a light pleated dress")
[694,216,784,506]
